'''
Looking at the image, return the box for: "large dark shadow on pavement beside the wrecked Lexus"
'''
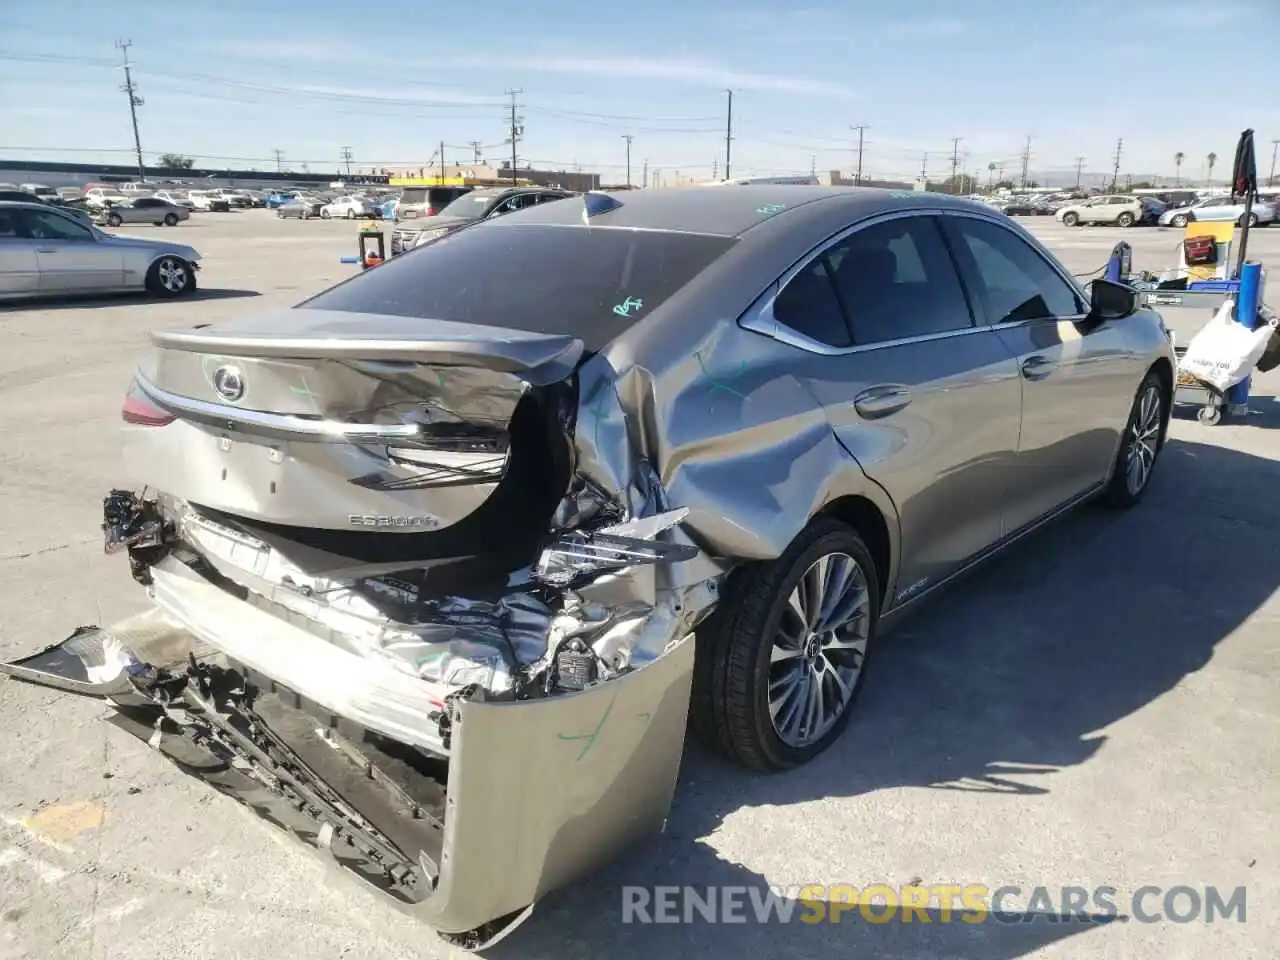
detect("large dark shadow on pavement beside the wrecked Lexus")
[485,440,1280,960]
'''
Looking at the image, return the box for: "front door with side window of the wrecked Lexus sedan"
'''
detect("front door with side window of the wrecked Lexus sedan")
[946,209,1140,534]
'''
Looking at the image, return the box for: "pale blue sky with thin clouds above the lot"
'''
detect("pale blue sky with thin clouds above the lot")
[0,0,1280,183]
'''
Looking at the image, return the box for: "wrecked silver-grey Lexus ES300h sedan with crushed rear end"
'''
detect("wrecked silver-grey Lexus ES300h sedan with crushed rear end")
[4,186,1174,947]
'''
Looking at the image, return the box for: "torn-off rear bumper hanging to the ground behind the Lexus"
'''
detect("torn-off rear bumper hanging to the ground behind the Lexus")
[0,609,694,948]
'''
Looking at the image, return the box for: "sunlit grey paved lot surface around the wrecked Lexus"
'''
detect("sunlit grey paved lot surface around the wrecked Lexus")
[0,211,1280,960]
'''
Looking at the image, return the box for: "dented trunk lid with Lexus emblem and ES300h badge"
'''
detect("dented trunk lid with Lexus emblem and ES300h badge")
[124,308,582,563]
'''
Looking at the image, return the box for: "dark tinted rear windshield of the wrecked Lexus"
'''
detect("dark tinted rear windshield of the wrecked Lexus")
[298,223,736,351]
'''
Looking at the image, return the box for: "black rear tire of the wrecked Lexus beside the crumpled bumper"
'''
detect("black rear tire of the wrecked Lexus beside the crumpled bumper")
[692,517,879,771]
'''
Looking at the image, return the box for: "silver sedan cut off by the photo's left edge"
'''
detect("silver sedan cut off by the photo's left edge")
[0,202,200,300]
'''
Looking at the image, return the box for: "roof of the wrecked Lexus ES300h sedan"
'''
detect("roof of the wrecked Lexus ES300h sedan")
[503,184,989,237]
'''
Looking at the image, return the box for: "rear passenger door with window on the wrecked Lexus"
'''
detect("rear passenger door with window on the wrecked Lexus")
[772,212,1020,600]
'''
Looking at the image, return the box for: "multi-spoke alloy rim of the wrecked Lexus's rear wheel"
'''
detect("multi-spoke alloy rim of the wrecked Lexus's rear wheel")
[768,553,872,748]
